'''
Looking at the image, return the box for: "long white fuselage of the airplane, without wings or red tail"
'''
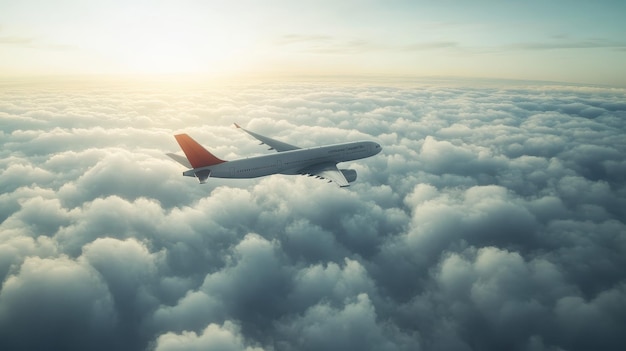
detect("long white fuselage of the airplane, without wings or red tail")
[183,141,382,178]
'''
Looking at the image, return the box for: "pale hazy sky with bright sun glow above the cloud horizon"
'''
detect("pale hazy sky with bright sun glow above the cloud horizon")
[0,0,626,87]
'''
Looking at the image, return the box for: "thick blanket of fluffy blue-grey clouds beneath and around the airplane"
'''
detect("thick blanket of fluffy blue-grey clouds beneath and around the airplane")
[0,82,626,350]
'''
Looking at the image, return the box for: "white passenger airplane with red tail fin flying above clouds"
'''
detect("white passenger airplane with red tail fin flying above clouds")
[167,123,382,187]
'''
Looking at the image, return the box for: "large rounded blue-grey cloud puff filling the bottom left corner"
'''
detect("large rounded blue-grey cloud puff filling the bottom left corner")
[0,256,119,350]
